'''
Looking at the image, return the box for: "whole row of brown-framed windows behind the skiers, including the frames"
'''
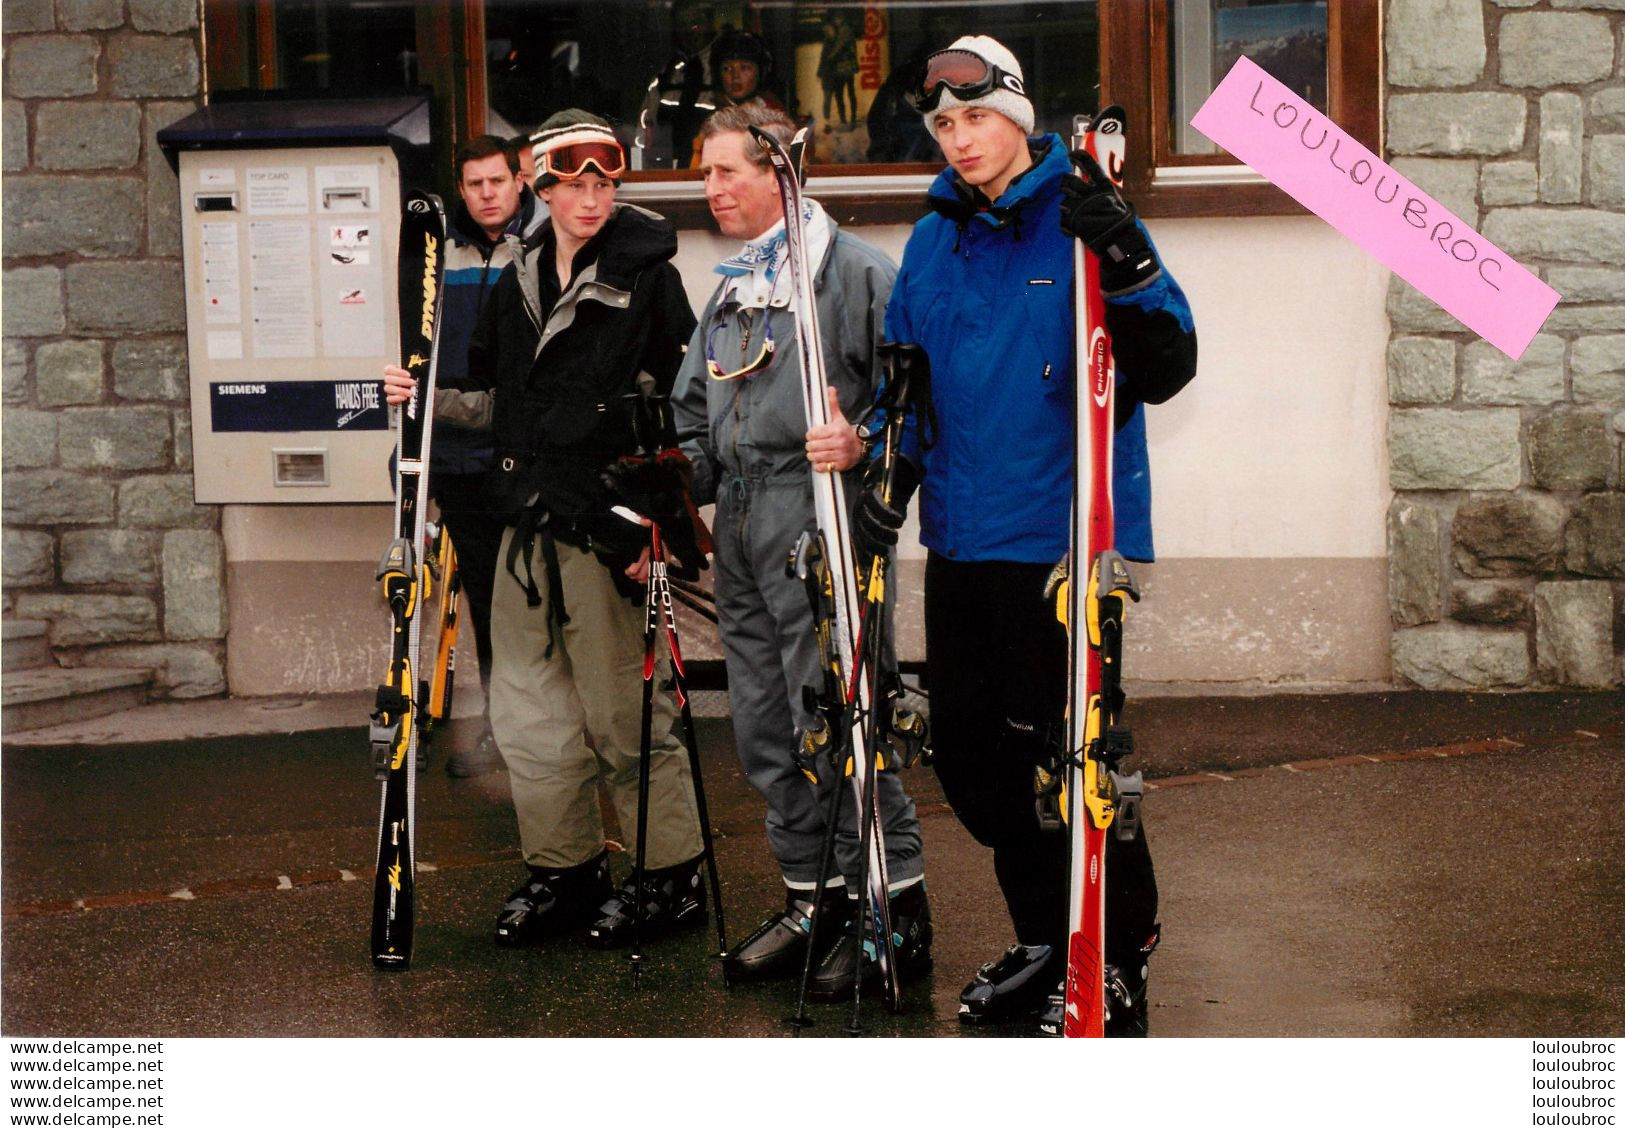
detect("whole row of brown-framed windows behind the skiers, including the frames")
[203,0,1380,224]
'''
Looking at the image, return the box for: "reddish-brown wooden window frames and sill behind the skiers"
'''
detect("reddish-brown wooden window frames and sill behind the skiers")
[203,0,1381,228]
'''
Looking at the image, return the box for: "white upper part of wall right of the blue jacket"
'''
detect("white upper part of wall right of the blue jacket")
[1147,216,1389,557]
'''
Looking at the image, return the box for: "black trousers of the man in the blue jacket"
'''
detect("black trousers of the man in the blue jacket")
[925,553,1157,967]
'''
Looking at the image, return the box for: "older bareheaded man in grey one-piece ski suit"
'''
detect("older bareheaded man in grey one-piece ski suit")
[673,102,931,1001]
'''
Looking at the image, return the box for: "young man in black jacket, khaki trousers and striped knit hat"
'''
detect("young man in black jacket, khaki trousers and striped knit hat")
[385,111,705,948]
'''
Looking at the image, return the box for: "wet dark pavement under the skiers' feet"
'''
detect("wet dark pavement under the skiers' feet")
[0,691,1625,1037]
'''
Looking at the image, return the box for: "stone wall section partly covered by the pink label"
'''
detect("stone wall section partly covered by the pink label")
[1385,0,1625,689]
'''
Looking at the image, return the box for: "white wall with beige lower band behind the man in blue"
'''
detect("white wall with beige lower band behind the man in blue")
[678,216,1389,688]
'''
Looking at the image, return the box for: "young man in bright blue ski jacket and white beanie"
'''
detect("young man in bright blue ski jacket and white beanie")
[856,36,1196,1034]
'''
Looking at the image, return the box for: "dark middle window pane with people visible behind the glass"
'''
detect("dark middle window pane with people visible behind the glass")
[484,0,1100,174]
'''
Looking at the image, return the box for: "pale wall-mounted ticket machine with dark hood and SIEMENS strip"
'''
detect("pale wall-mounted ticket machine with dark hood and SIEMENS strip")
[158,96,431,504]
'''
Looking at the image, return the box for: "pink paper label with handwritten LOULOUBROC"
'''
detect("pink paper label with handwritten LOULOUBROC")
[1191,57,1560,359]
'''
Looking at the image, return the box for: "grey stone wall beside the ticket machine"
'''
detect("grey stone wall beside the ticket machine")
[0,0,226,696]
